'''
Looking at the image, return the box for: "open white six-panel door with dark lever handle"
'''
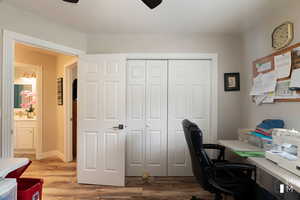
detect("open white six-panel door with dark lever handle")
[77,55,126,186]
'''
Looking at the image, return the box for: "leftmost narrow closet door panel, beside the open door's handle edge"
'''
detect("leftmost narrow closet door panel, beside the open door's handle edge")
[126,60,146,176]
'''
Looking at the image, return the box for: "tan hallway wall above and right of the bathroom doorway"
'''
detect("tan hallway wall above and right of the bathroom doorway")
[15,47,59,152]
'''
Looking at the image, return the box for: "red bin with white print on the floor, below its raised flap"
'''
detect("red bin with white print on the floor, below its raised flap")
[17,178,43,200]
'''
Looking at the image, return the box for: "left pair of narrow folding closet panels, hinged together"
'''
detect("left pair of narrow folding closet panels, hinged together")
[126,60,168,176]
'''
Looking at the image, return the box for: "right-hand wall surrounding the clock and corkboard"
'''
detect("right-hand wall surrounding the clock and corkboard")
[242,1,300,129]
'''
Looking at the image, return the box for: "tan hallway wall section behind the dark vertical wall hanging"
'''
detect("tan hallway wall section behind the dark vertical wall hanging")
[56,55,77,153]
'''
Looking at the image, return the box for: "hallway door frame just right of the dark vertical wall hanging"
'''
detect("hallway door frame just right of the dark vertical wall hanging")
[63,60,78,162]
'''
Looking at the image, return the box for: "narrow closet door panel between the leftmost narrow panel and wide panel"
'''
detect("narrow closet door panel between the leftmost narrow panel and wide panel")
[146,60,168,176]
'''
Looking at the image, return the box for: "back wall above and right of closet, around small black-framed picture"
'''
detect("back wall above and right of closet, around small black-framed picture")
[87,34,242,139]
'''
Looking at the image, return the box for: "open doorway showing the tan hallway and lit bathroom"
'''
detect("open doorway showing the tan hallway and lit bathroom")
[12,42,77,162]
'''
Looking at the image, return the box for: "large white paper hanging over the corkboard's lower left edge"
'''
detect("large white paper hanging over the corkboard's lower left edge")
[250,71,277,96]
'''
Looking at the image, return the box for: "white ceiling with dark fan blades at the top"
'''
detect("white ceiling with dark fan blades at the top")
[3,0,286,34]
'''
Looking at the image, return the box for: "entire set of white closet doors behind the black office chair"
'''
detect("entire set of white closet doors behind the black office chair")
[126,60,212,176]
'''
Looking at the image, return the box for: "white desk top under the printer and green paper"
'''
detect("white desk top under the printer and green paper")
[219,140,300,193]
